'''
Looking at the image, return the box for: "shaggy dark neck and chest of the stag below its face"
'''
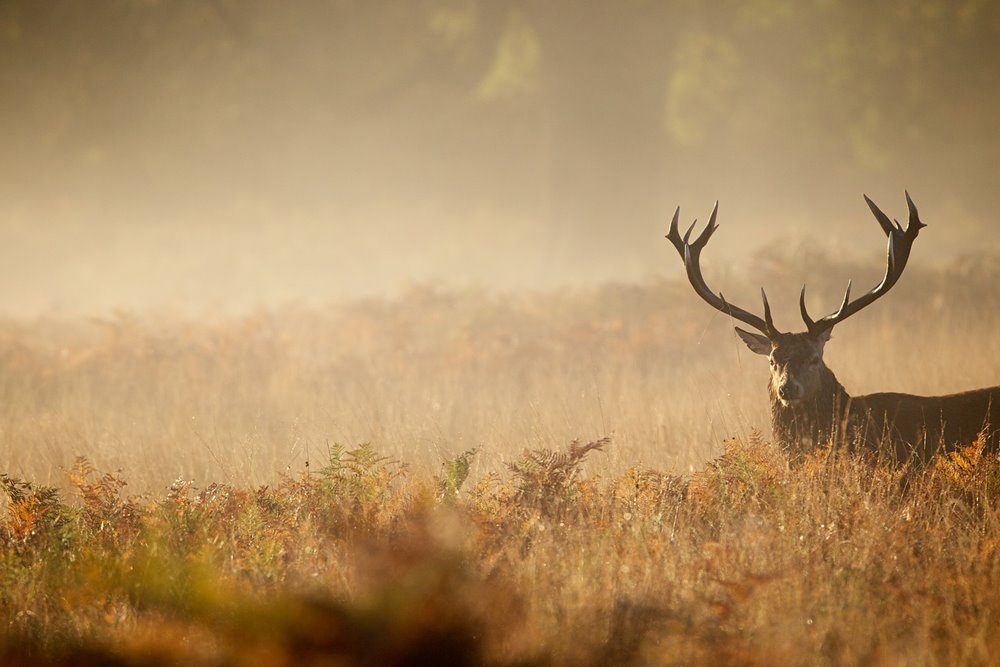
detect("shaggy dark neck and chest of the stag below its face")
[768,366,851,458]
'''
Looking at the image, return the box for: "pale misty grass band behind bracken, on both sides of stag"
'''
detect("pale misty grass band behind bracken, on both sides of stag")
[0,250,1000,490]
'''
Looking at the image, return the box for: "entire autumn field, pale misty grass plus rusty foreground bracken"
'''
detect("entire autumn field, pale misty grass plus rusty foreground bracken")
[0,253,1000,665]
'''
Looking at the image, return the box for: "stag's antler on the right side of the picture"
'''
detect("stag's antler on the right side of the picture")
[799,192,927,336]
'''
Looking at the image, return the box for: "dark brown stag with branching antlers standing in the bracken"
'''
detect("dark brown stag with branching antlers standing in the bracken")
[667,195,1000,462]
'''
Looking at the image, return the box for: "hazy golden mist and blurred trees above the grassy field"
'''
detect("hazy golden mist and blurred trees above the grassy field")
[0,0,1000,317]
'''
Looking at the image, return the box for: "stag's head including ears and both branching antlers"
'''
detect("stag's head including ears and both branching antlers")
[667,193,926,407]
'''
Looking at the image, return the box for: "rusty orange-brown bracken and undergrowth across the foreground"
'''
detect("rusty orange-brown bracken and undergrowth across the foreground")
[0,437,1000,665]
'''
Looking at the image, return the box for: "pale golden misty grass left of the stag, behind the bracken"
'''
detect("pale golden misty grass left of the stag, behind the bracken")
[0,284,759,490]
